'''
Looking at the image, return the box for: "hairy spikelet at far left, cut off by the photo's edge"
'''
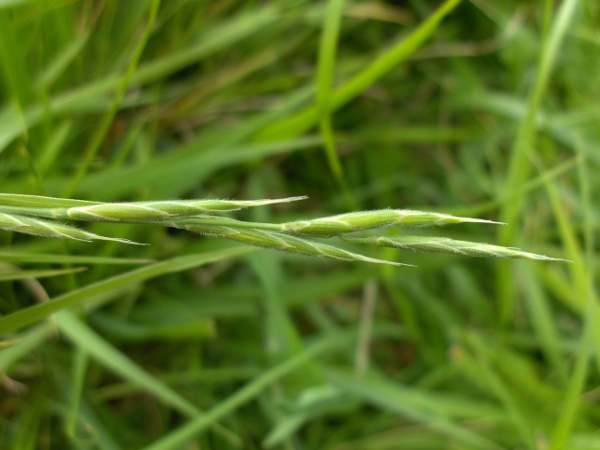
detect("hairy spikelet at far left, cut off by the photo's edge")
[0,213,135,244]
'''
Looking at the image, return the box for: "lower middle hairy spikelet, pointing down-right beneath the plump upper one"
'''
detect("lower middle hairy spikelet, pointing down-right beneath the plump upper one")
[180,225,410,266]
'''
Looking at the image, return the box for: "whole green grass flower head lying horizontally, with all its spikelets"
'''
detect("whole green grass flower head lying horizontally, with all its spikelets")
[0,194,558,266]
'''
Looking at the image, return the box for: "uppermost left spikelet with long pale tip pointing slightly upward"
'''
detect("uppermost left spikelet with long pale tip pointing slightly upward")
[64,197,306,222]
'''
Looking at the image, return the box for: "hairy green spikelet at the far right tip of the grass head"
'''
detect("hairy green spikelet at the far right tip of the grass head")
[344,236,565,261]
